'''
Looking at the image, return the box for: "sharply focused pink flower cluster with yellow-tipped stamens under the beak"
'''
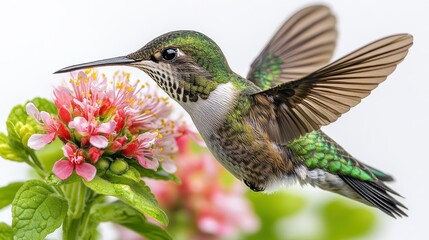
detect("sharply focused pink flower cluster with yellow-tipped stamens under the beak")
[26,69,178,181]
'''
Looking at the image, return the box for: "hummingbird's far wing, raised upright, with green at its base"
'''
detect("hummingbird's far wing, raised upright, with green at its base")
[247,5,337,89]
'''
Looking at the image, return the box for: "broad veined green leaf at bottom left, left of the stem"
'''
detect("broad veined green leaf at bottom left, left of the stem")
[12,180,68,239]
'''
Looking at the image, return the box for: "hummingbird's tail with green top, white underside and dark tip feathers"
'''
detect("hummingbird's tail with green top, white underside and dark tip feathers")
[287,131,407,218]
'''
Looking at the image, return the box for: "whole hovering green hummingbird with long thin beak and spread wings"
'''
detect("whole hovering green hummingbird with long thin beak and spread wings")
[55,5,413,218]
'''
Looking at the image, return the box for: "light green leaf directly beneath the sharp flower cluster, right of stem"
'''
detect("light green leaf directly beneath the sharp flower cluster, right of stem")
[83,176,168,225]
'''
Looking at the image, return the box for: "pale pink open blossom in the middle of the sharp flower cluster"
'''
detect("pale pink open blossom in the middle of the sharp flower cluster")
[69,117,116,148]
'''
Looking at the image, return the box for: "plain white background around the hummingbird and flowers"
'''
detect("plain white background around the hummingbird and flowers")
[0,0,429,239]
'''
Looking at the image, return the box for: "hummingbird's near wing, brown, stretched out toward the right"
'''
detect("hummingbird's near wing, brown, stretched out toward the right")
[249,34,413,144]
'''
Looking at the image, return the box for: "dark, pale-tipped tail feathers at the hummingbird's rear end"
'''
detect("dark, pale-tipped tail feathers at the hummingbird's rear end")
[340,176,408,218]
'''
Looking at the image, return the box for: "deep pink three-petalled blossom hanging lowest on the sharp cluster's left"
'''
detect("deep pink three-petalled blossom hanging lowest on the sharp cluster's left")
[52,143,97,182]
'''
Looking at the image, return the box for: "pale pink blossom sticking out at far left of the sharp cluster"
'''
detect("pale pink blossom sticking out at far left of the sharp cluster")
[26,103,70,150]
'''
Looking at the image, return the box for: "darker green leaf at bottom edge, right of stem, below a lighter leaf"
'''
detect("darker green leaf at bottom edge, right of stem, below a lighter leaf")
[91,201,172,240]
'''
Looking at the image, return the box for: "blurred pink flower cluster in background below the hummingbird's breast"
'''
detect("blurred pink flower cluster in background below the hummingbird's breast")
[142,132,259,239]
